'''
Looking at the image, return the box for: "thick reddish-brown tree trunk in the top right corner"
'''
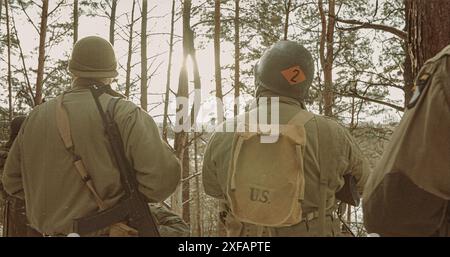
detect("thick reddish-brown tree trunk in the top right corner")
[405,0,450,78]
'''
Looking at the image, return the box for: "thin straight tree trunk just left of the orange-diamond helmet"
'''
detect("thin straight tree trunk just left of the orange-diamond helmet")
[234,0,241,116]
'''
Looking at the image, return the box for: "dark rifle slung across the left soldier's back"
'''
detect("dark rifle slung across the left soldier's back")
[74,85,160,237]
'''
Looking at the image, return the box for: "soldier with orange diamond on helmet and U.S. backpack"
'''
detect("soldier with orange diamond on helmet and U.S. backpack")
[203,41,368,236]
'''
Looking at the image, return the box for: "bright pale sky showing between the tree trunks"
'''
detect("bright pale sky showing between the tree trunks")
[0,0,403,122]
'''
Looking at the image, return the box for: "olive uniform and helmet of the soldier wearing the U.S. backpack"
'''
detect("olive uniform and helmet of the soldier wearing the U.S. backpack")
[203,41,369,236]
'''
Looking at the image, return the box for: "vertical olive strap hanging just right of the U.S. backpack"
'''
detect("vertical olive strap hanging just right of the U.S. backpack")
[316,117,333,236]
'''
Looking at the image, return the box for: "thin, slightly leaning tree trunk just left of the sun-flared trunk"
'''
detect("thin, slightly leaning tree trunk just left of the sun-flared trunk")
[162,0,175,142]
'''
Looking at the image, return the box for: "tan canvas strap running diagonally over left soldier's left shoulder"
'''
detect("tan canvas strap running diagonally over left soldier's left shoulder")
[56,94,107,210]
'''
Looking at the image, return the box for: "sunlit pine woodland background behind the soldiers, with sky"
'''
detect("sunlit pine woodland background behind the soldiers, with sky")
[0,0,450,236]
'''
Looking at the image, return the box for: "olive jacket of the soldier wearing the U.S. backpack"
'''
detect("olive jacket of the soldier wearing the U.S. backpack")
[203,94,368,236]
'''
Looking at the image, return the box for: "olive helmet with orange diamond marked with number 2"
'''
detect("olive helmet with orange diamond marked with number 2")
[254,40,314,102]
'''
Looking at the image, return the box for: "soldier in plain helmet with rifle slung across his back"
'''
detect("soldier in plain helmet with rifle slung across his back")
[3,37,180,236]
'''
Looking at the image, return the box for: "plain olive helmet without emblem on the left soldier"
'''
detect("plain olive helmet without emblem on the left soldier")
[69,36,118,78]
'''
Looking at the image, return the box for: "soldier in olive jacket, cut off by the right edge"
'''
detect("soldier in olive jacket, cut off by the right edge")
[363,45,450,236]
